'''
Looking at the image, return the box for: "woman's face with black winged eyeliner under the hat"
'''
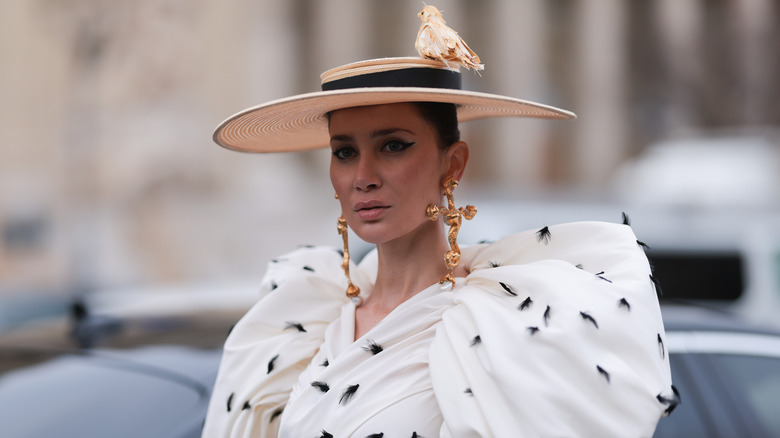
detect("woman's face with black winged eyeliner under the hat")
[330,103,465,244]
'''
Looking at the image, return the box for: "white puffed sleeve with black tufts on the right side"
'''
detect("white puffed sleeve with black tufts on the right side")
[430,222,672,438]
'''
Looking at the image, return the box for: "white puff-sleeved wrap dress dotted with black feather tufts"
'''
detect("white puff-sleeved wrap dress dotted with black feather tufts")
[203,222,675,438]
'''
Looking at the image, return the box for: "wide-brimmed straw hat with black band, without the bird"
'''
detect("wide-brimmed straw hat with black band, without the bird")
[214,58,576,152]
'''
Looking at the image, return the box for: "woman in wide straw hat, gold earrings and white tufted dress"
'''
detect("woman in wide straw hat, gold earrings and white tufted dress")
[204,5,676,438]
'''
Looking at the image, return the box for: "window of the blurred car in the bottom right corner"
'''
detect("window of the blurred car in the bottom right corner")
[711,354,780,436]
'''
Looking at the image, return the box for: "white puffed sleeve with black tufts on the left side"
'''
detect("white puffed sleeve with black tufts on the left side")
[203,248,346,438]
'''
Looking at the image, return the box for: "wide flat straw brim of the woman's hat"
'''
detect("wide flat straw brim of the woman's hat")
[214,57,576,152]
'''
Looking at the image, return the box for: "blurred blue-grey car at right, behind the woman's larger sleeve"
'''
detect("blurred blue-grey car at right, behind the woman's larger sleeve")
[654,305,780,438]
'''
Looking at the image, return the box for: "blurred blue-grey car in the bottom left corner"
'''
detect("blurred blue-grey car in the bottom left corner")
[0,346,220,438]
